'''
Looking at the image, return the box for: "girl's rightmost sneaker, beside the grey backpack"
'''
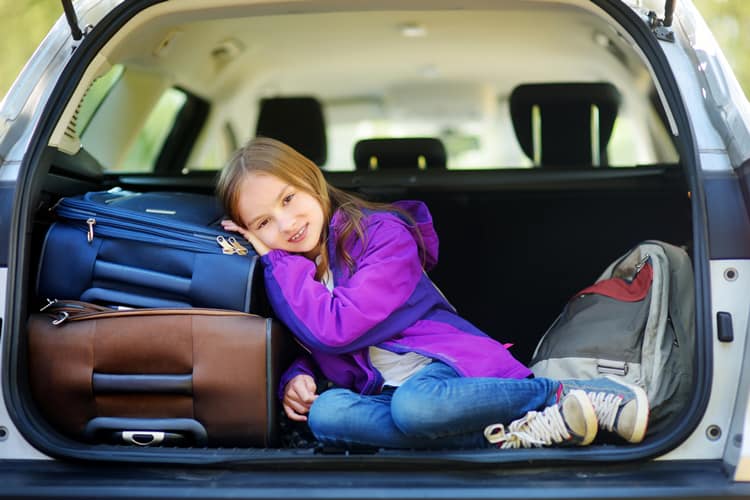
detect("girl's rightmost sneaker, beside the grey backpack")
[562,377,649,443]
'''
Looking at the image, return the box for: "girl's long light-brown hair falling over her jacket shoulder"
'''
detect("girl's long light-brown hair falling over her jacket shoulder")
[216,137,412,279]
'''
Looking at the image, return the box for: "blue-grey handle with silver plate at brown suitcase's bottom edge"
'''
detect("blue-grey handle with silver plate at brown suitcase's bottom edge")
[83,417,208,446]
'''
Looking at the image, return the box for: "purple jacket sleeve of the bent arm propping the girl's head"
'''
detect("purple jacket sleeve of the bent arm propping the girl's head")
[263,216,423,353]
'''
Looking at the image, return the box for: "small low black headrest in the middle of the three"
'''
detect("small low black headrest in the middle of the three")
[354,137,446,170]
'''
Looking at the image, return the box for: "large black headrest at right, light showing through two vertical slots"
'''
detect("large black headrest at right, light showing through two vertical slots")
[510,82,621,167]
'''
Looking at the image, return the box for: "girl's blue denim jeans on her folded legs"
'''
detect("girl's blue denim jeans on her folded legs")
[308,361,560,449]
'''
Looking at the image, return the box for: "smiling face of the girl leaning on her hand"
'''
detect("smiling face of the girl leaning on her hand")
[237,172,325,259]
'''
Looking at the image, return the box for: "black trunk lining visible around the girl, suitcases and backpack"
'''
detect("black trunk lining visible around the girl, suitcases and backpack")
[7,154,692,462]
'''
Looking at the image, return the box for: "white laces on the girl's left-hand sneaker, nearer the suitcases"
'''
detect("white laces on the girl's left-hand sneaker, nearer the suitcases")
[484,405,571,448]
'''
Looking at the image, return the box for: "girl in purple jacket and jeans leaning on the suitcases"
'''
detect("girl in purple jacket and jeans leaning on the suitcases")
[217,138,648,448]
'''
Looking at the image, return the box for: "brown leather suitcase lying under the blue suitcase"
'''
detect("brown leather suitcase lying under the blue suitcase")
[28,301,296,447]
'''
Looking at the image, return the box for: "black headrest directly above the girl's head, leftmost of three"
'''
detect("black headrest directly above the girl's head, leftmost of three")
[255,96,328,166]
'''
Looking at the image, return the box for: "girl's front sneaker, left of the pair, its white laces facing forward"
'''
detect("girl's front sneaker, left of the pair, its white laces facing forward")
[484,390,597,448]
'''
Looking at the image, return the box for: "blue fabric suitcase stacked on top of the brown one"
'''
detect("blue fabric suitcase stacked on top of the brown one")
[36,189,268,314]
